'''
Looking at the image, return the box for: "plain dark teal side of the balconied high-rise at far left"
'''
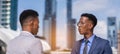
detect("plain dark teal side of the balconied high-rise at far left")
[10,0,18,30]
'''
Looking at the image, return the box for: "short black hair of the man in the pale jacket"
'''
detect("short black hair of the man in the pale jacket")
[20,9,39,25]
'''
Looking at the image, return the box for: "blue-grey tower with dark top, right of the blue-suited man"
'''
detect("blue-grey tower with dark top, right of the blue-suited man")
[107,17,117,48]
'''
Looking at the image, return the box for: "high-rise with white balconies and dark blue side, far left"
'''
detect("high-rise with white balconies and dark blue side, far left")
[0,0,17,30]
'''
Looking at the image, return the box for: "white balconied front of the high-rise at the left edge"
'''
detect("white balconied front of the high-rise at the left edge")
[0,0,11,28]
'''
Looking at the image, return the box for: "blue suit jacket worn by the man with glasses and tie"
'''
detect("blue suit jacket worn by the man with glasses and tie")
[71,36,112,54]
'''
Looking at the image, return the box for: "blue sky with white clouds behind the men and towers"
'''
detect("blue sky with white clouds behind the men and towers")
[18,0,120,47]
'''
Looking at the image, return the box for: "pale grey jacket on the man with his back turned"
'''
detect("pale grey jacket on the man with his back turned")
[6,31,43,54]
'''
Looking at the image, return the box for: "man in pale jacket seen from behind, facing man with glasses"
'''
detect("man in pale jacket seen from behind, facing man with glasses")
[6,9,42,54]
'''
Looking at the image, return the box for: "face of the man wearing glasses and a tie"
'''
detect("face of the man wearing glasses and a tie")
[77,16,92,35]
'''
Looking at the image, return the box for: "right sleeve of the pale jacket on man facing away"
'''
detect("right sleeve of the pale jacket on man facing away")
[29,40,43,54]
